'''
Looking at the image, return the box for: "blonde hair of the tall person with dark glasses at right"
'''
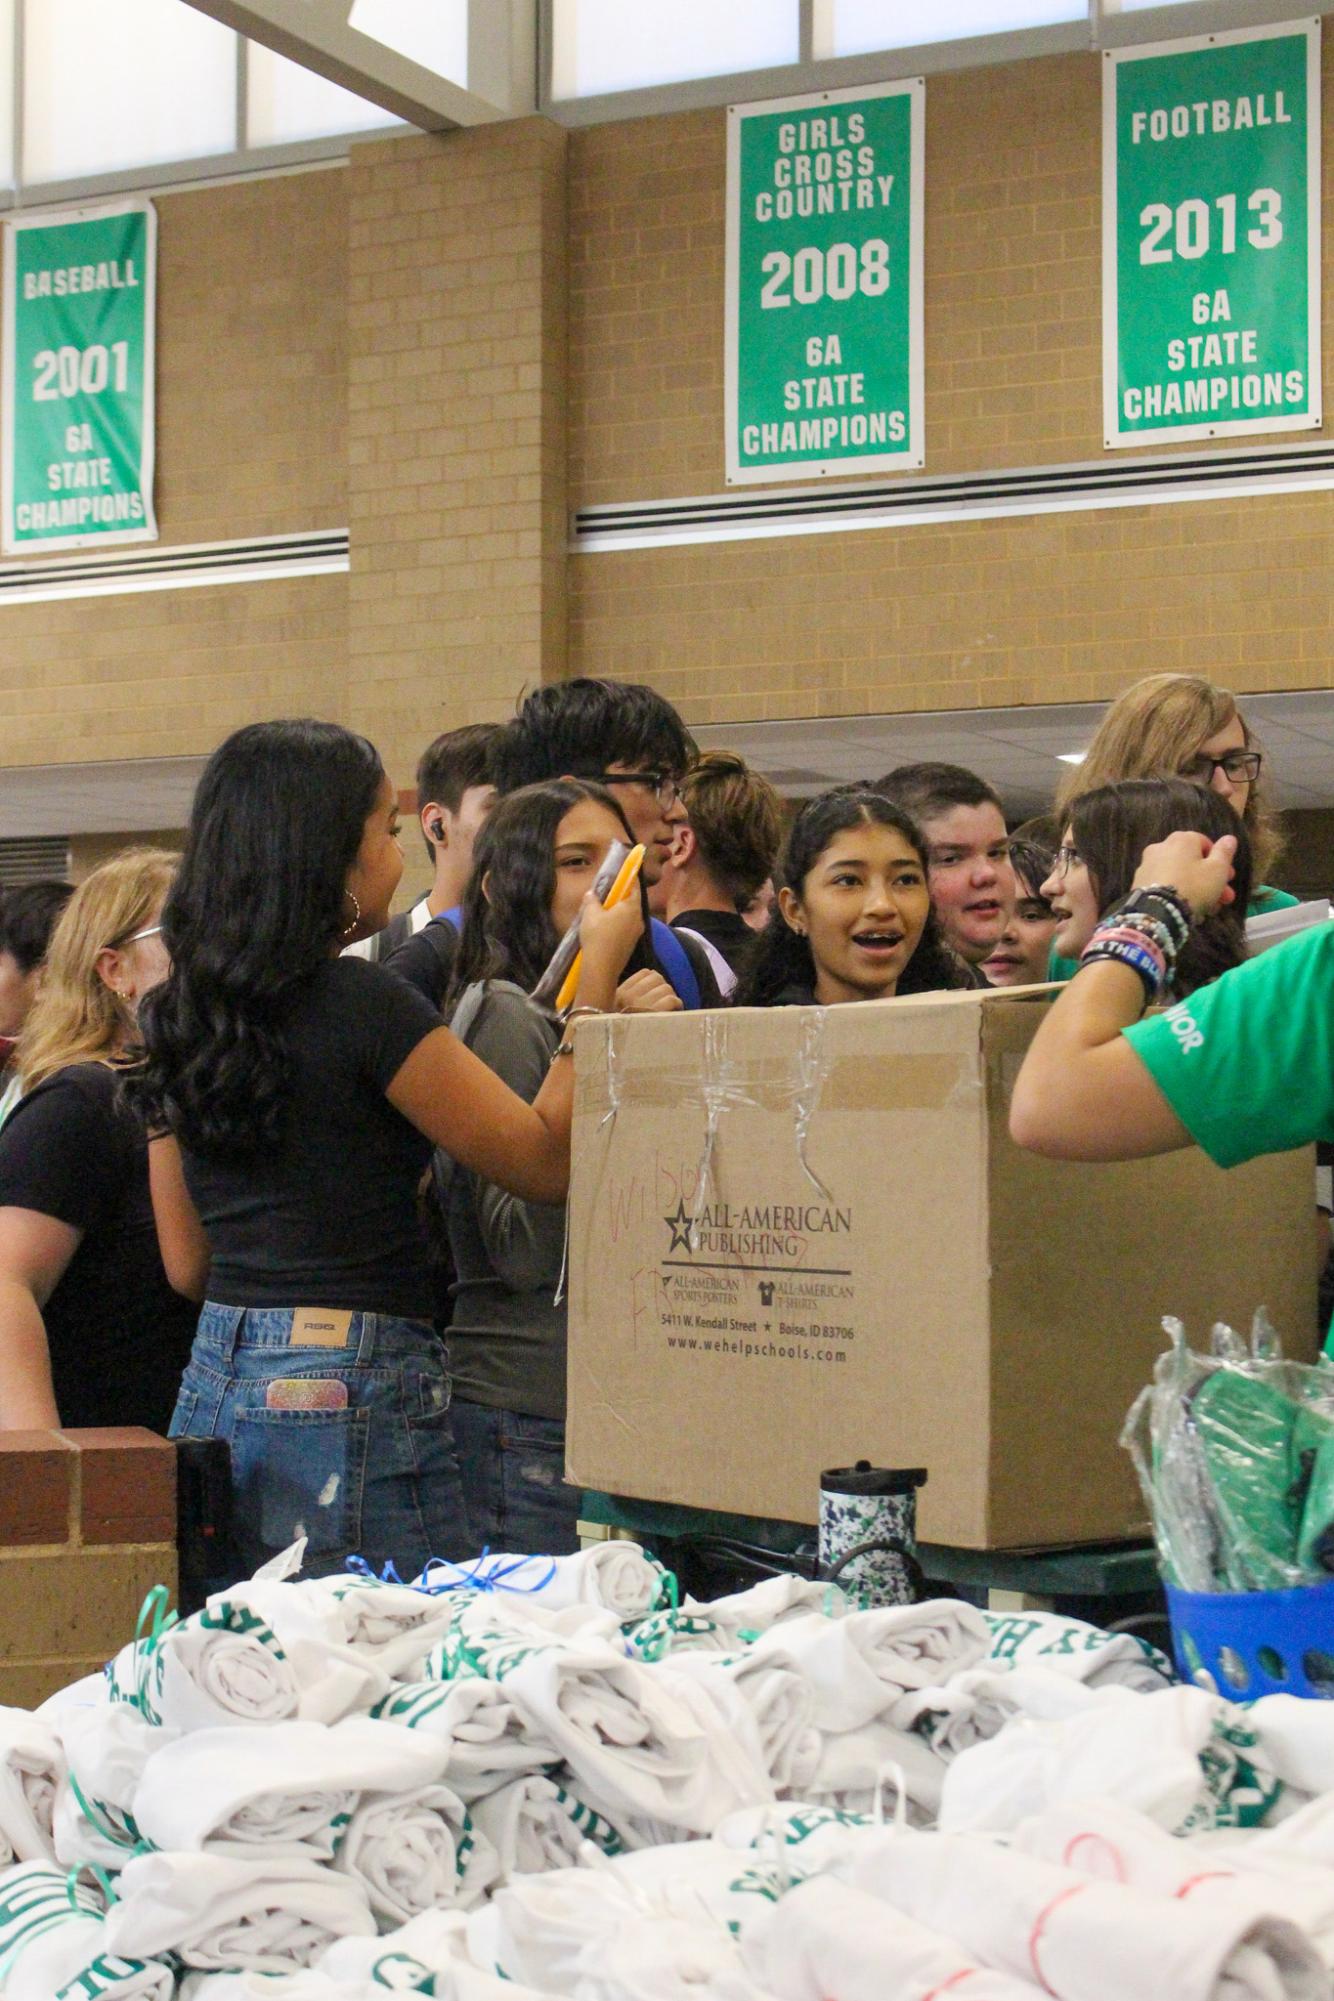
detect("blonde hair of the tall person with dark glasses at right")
[1056,674,1282,884]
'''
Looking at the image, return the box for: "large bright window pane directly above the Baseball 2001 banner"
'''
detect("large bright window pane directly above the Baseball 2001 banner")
[22,0,236,184]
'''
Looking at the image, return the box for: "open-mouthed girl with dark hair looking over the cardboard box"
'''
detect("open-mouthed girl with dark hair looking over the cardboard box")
[732,784,968,1007]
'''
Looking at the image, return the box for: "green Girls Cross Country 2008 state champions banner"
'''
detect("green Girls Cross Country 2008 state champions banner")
[726,76,924,484]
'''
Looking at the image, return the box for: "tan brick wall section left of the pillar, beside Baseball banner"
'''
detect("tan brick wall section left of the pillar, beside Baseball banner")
[0,170,348,764]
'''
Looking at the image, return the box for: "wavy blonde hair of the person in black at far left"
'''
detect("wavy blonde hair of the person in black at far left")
[18,848,178,1091]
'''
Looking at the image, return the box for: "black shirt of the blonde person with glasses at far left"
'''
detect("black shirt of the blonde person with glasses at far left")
[0,1063,200,1431]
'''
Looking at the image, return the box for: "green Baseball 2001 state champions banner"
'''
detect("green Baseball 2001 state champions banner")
[0,202,158,554]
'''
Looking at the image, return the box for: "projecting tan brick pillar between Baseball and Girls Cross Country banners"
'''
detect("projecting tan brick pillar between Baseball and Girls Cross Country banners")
[348,118,566,784]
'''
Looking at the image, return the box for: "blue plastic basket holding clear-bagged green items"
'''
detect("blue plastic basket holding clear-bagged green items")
[1166,1579,1334,1703]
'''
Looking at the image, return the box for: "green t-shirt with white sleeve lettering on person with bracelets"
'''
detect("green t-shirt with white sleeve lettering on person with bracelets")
[1124,922,1334,1167]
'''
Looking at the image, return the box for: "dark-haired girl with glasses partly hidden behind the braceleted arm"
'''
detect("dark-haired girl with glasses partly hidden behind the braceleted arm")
[1042,778,1250,1001]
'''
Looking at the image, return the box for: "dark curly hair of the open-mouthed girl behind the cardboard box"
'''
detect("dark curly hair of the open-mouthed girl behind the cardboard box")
[732,784,968,1007]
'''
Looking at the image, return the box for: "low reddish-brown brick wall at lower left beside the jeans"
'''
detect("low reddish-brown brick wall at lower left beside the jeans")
[0,1427,176,1709]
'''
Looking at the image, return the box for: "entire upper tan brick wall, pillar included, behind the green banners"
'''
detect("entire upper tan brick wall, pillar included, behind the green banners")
[0,50,1334,812]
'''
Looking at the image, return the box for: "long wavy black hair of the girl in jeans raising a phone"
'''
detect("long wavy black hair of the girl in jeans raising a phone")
[126,720,384,1159]
